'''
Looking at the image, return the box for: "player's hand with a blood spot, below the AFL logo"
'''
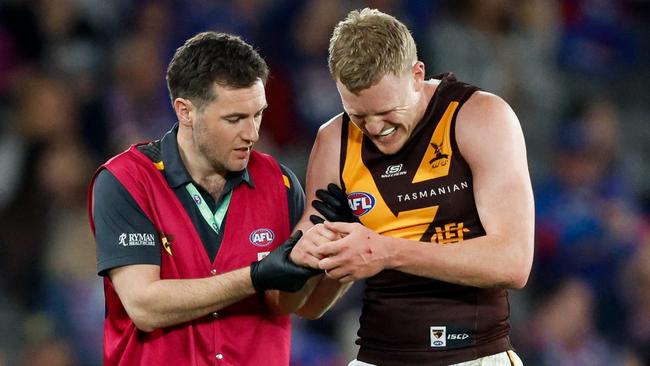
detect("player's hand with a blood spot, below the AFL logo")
[316,222,394,282]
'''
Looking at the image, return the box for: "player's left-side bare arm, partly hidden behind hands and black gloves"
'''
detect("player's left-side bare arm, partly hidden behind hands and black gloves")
[291,115,351,319]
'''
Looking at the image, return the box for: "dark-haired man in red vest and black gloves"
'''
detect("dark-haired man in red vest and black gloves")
[89,32,322,365]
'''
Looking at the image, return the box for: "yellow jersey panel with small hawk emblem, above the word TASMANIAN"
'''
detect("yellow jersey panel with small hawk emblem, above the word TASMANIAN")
[412,102,458,183]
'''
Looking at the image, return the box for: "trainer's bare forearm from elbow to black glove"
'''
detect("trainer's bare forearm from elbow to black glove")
[119,267,255,331]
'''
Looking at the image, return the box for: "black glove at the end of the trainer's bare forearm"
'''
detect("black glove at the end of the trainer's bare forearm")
[251,230,323,293]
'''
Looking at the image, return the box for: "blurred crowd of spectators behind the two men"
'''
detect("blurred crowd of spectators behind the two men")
[0,0,650,366]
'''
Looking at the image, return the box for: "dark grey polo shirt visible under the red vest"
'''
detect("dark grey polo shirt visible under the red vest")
[93,126,305,275]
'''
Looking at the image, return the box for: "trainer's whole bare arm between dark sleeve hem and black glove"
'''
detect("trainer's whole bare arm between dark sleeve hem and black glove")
[109,264,254,331]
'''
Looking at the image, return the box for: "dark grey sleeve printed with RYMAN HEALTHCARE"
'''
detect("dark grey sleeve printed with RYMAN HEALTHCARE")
[93,169,160,276]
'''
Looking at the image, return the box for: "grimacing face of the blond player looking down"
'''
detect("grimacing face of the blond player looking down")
[336,73,419,154]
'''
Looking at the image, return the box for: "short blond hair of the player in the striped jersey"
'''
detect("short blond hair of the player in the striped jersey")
[328,8,417,94]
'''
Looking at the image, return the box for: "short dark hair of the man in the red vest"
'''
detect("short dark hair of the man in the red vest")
[166,32,269,110]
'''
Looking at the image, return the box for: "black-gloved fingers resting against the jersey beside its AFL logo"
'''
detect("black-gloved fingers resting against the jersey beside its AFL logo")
[309,183,359,225]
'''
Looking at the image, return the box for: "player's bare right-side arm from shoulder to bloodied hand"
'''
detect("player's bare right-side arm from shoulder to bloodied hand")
[317,92,534,288]
